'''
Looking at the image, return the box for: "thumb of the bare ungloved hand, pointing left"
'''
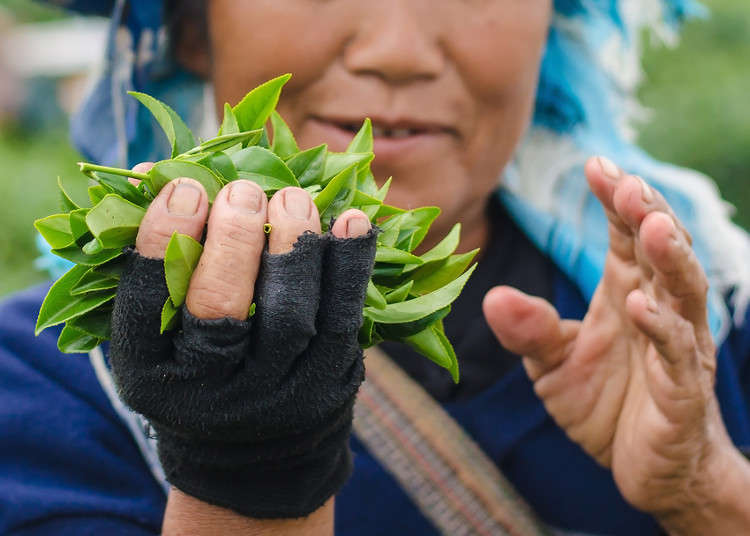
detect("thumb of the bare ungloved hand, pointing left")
[482,287,578,381]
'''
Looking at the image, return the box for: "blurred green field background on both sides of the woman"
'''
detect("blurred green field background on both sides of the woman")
[0,0,750,296]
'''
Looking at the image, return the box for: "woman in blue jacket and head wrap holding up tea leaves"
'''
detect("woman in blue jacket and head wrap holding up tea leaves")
[0,0,750,534]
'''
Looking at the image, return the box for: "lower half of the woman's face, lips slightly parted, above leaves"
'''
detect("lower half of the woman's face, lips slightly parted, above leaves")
[209,0,552,249]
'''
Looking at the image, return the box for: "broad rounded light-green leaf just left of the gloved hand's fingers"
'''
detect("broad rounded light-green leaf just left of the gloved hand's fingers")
[86,194,146,249]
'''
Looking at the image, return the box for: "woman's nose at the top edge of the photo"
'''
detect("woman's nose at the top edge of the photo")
[344,0,445,84]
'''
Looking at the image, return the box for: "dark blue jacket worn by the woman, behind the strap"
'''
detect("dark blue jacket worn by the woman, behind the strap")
[0,276,750,536]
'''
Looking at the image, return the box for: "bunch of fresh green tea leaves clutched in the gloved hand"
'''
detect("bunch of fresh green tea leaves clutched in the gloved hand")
[35,75,477,382]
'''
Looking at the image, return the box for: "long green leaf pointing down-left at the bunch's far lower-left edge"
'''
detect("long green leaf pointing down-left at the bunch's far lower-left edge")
[35,266,115,335]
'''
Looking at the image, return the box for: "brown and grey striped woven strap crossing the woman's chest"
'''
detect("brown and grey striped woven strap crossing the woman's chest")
[354,348,550,536]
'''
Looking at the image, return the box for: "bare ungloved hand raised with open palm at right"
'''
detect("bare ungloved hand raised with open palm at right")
[484,159,732,516]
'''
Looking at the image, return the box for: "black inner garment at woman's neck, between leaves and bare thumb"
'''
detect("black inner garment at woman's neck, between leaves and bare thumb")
[381,195,558,403]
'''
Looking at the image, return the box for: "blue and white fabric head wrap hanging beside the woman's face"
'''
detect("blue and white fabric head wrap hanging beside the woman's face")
[41,0,750,342]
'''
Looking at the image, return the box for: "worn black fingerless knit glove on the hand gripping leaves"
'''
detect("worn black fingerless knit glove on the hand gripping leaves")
[110,230,377,518]
